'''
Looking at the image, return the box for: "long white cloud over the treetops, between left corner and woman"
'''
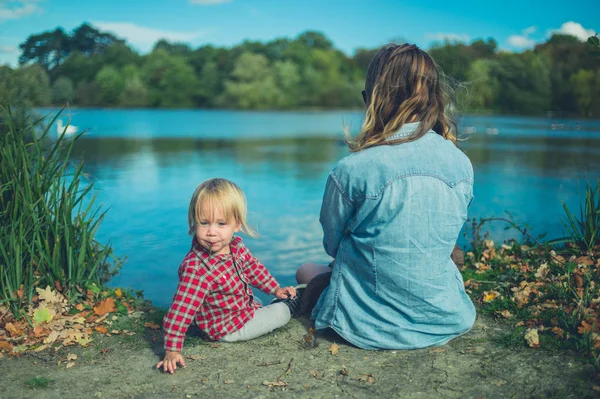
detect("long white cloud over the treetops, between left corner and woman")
[92,21,207,51]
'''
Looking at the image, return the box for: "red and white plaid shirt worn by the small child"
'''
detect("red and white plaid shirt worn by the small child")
[163,237,279,352]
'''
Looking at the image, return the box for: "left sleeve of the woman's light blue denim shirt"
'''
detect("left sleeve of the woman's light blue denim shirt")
[319,175,354,258]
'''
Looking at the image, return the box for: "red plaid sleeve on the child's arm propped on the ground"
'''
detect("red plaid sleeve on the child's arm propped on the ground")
[163,265,210,352]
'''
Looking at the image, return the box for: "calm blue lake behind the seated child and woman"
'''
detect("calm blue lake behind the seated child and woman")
[44,109,600,306]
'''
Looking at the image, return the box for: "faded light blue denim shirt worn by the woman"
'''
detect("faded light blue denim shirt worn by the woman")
[312,122,475,349]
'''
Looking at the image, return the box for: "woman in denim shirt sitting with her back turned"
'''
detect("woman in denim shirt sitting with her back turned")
[296,44,475,349]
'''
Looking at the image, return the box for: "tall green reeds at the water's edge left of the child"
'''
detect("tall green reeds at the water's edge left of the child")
[0,107,120,315]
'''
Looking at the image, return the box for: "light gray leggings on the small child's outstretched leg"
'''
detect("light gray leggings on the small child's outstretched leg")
[219,302,292,342]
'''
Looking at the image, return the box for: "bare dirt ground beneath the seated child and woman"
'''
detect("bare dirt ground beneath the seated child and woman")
[0,317,600,399]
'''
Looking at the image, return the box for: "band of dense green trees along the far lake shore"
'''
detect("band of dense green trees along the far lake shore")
[0,24,600,117]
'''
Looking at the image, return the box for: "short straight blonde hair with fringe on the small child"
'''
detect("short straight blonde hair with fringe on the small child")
[188,178,258,237]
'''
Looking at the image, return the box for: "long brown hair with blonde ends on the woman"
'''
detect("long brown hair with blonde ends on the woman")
[344,44,456,152]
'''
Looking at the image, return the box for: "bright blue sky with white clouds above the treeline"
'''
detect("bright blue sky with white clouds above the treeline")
[0,0,600,66]
